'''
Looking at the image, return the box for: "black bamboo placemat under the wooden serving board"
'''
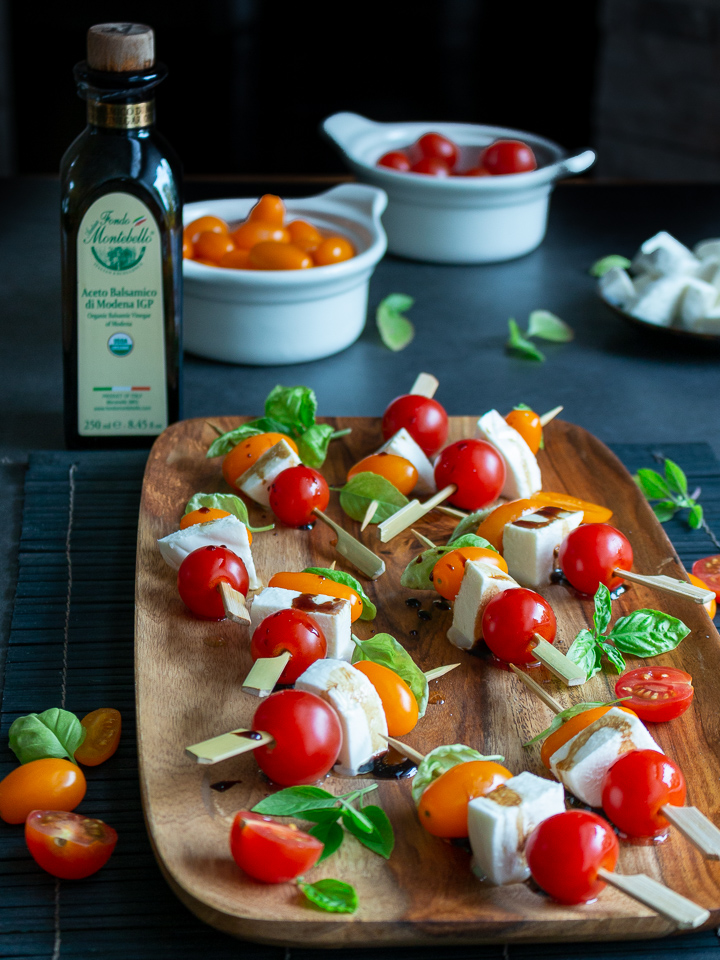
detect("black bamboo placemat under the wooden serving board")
[0,444,720,960]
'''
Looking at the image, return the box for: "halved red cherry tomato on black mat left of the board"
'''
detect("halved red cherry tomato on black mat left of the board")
[25,810,117,880]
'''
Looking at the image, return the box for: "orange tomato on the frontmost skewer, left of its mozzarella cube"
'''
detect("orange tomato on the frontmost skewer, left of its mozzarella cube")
[416,760,512,838]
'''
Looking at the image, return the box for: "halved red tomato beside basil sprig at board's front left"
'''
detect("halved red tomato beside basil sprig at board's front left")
[230,810,323,883]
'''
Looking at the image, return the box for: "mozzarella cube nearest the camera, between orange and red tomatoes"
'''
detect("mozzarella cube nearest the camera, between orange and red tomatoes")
[468,772,565,886]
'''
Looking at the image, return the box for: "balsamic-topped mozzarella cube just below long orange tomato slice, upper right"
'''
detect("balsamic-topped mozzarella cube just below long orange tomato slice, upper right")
[503,507,583,587]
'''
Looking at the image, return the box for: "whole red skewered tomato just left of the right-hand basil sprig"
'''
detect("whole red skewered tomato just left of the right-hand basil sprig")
[483,587,557,663]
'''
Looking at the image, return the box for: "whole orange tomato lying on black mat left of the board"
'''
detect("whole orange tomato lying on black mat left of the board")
[0,757,86,823]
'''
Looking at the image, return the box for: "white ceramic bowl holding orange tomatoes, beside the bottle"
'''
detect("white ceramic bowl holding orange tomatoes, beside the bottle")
[183,183,387,366]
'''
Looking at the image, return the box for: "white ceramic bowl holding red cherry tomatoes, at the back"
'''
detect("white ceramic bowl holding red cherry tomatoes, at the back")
[322,113,595,263]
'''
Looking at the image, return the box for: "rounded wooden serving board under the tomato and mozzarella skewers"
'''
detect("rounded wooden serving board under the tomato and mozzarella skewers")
[135,417,720,947]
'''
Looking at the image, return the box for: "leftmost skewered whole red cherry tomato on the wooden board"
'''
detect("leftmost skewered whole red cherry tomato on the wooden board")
[178,546,249,620]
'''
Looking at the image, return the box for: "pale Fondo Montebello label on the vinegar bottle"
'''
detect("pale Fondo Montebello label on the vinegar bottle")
[77,193,168,437]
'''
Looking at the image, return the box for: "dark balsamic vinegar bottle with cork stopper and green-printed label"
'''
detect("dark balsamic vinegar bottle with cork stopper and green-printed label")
[61,23,182,448]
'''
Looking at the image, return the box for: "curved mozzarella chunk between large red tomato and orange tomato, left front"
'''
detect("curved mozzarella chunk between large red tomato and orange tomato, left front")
[295,656,388,777]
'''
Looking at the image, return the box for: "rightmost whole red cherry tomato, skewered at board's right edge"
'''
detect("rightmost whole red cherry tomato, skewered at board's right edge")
[602,750,685,837]
